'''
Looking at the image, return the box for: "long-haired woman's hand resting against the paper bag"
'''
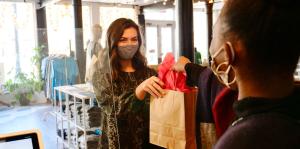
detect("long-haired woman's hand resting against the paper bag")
[135,76,166,100]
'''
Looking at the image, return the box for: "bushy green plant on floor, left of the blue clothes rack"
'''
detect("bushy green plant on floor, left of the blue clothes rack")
[4,73,42,106]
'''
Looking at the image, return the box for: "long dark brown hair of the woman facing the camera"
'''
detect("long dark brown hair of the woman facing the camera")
[106,18,147,80]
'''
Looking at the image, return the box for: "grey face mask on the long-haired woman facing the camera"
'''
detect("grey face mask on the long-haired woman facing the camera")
[118,45,139,60]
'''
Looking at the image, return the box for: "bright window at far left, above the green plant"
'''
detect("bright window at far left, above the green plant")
[0,2,36,83]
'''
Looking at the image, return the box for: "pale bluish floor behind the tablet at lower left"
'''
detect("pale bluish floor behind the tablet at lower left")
[0,105,57,149]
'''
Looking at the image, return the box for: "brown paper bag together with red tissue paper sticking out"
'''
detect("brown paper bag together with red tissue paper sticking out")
[150,54,197,149]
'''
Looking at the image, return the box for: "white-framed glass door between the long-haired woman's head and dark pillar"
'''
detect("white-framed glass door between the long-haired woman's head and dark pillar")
[144,8,177,65]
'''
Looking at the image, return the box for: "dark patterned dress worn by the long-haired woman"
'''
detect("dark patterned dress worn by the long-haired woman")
[93,68,156,149]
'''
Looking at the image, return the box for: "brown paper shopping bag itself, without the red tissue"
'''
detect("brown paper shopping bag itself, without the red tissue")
[150,90,197,149]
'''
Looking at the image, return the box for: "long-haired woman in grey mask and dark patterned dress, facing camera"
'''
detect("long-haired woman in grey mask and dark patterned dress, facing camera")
[93,18,164,149]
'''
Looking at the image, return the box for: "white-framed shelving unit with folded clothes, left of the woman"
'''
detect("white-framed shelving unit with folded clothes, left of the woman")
[51,84,95,148]
